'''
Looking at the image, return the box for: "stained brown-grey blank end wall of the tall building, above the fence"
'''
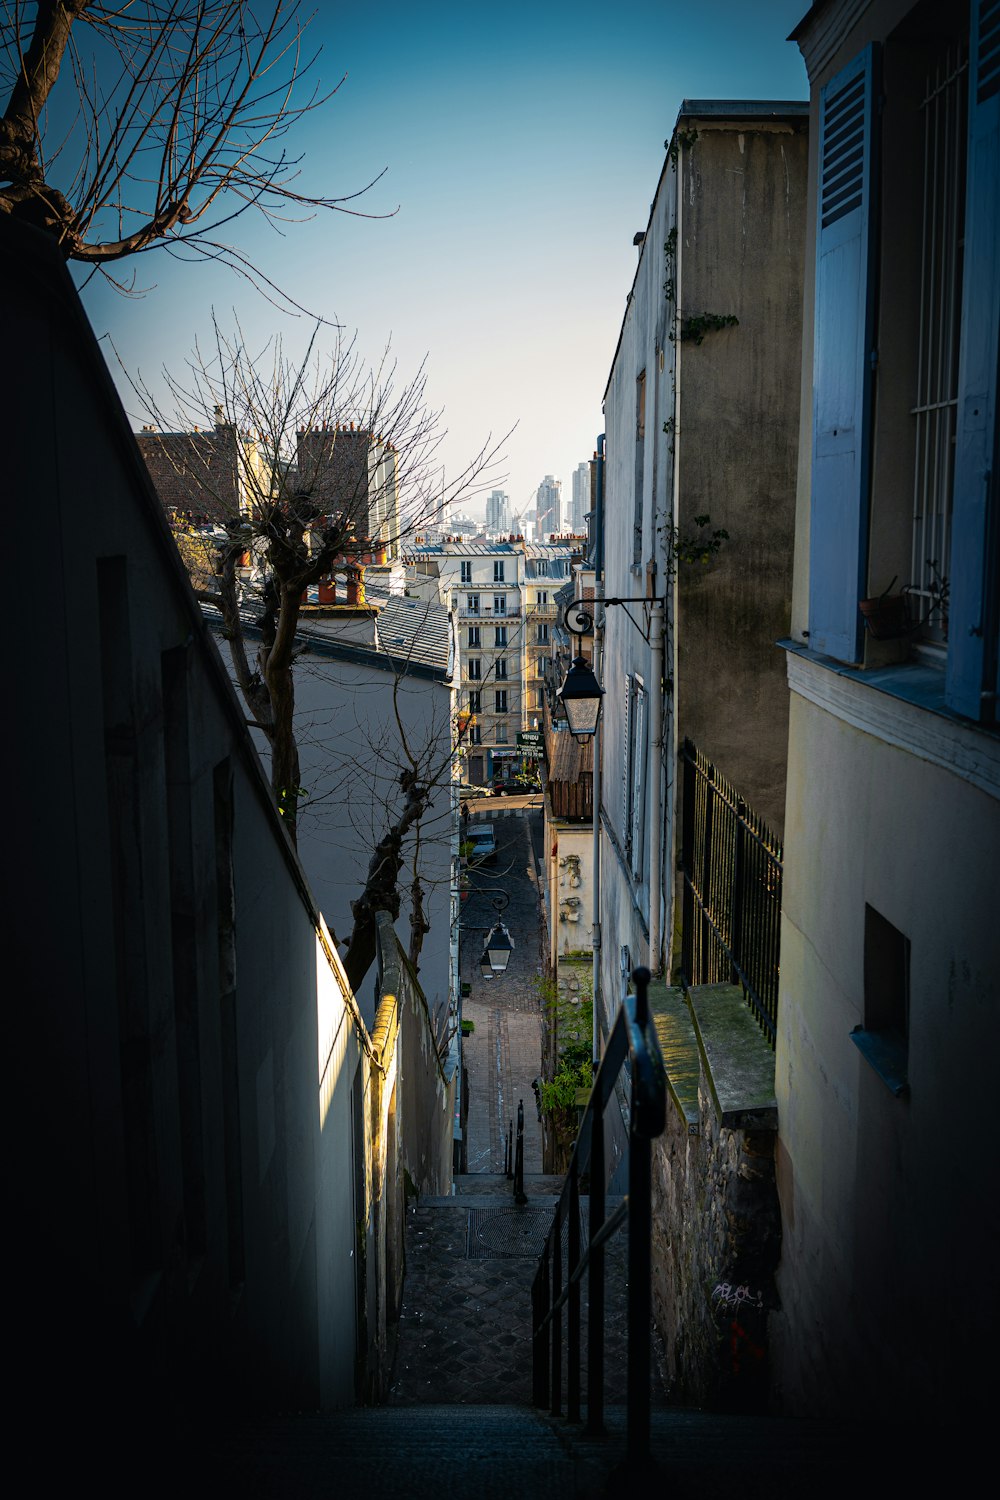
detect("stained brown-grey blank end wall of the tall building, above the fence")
[676,119,808,834]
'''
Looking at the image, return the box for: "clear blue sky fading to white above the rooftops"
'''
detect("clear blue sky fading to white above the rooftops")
[82,0,808,531]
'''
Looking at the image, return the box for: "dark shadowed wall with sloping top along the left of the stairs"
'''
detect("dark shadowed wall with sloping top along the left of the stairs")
[7,227,380,1469]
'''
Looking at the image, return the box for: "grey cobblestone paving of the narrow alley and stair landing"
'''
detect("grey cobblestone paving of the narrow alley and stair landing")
[390,813,661,1406]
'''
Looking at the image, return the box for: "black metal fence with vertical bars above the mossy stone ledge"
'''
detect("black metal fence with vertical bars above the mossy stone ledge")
[681,740,781,1047]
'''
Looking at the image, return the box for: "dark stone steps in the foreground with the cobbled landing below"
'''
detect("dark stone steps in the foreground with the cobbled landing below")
[189,1173,917,1500]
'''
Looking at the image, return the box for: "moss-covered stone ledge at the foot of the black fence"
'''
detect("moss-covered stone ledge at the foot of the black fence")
[688,984,778,1130]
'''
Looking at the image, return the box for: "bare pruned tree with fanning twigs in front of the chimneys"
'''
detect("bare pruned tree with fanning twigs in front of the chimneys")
[132,324,501,869]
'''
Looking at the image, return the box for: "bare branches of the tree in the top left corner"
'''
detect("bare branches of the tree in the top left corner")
[0,0,377,303]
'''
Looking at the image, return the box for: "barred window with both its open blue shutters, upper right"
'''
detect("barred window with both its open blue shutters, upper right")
[808,11,1000,722]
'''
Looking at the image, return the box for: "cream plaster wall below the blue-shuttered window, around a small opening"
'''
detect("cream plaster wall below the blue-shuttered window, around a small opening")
[772,687,1000,1419]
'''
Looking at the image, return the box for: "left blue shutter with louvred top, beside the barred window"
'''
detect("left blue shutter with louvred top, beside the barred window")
[810,47,874,662]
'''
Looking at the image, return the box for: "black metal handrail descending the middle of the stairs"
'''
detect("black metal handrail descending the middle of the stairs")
[531,969,667,1467]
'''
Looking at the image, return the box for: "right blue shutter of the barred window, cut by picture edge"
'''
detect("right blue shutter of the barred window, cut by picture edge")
[945,0,1000,719]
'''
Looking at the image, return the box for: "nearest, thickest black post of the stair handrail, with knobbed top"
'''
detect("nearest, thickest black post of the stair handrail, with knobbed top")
[627,969,652,1469]
